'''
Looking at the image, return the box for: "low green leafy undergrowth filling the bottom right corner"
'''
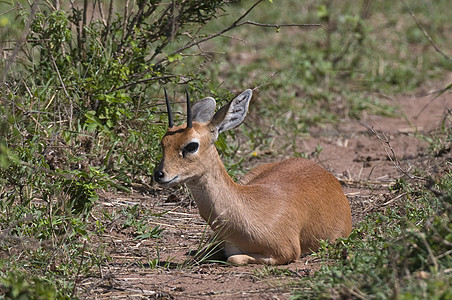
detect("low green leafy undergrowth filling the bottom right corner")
[296,172,452,299]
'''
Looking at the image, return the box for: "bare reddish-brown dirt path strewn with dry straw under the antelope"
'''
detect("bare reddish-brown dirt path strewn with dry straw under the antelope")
[79,78,452,299]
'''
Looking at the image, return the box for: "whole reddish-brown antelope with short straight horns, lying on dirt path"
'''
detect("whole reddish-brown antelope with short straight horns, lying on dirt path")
[154,89,352,265]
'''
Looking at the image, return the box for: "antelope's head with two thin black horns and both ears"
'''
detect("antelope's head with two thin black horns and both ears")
[154,89,252,187]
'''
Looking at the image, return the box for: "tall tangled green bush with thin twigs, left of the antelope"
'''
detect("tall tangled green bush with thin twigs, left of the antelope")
[0,0,230,299]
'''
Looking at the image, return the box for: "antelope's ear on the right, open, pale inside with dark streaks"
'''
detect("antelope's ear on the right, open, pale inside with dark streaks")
[210,89,253,133]
